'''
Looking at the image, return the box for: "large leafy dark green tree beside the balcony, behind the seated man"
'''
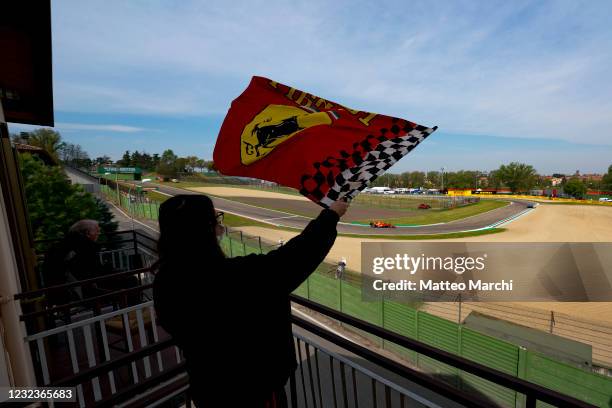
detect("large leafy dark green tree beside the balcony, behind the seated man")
[19,153,117,240]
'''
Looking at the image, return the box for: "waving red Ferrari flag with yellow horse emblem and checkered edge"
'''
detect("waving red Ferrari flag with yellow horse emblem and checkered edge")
[213,77,437,207]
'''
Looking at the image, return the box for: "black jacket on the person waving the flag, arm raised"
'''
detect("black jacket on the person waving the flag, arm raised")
[153,209,338,408]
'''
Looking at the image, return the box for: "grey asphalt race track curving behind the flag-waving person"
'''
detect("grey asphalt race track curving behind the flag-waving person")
[149,184,533,236]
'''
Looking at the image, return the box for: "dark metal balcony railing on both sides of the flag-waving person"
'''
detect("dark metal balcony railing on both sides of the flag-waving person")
[9,288,592,407]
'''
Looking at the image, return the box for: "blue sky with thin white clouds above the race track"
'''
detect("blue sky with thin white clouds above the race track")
[11,0,612,173]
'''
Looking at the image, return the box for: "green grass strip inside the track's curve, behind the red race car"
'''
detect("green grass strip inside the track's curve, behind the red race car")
[358,201,508,225]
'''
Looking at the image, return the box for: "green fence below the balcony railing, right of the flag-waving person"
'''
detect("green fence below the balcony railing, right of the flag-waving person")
[294,268,612,408]
